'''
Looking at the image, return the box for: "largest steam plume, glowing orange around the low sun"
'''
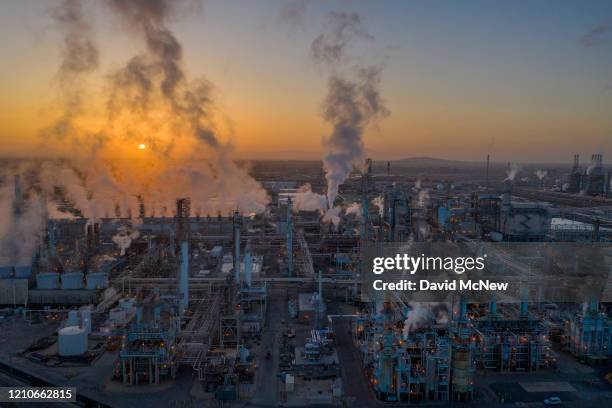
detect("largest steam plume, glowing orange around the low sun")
[36,0,268,223]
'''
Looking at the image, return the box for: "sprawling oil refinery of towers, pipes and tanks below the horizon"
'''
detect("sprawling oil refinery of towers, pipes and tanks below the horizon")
[0,154,612,407]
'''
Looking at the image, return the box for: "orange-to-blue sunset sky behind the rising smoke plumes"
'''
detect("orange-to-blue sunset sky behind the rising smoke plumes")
[0,0,612,163]
